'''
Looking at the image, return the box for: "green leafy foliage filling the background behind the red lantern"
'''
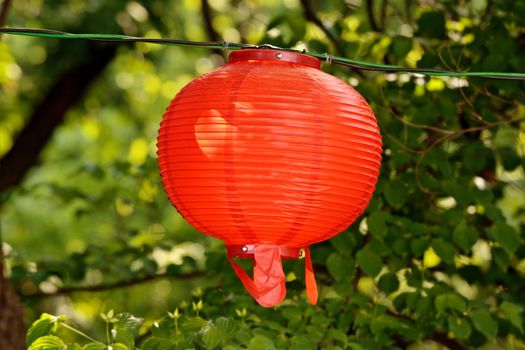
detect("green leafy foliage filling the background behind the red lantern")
[0,0,525,349]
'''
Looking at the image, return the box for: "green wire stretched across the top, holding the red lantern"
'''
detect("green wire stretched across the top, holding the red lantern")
[0,28,525,80]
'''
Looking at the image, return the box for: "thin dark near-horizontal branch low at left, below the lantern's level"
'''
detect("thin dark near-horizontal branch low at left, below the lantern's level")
[22,271,205,299]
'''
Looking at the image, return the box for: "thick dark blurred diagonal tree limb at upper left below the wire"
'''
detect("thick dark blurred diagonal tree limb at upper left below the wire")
[0,45,116,193]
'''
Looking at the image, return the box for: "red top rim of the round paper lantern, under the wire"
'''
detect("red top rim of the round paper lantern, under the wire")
[228,49,321,69]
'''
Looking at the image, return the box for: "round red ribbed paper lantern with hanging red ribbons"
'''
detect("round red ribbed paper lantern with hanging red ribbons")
[157,49,381,307]
